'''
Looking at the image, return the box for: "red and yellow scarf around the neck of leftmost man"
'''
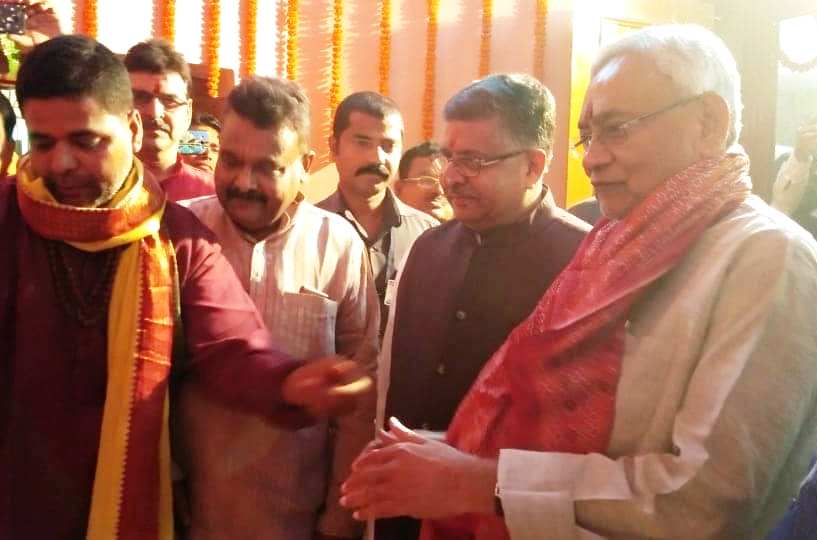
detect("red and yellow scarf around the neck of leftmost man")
[17,160,175,539]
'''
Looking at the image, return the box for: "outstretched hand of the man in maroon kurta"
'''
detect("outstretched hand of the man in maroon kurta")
[282,356,373,418]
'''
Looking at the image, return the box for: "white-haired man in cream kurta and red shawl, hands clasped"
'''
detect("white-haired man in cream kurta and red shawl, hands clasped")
[341,25,817,540]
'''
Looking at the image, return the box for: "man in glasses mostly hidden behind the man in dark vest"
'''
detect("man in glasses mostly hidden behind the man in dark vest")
[394,141,454,222]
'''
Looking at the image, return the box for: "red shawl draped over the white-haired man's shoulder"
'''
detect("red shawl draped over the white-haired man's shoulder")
[421,154,751,540]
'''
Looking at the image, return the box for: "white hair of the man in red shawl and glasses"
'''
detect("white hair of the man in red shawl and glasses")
[590,24,743,147]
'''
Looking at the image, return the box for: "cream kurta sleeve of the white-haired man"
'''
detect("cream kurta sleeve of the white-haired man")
[498,221,817,540]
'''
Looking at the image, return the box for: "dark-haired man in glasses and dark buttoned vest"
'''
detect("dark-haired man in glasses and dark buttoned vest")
[368,75,590,539]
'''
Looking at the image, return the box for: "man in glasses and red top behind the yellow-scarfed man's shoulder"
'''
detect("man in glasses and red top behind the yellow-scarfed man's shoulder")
[125,39,215,201]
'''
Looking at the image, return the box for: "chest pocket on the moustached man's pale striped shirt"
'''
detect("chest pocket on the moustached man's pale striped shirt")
[270,293,338,360]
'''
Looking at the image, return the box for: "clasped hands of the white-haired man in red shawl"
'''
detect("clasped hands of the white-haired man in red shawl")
[340,418,496,520]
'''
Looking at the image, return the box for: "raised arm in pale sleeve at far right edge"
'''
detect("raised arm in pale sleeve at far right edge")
[772,117,817,236]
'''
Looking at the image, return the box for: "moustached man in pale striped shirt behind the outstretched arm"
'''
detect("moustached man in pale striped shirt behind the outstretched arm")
[180,78,379,540]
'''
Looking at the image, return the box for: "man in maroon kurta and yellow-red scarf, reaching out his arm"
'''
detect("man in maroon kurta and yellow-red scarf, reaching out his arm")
[0,36,371,539]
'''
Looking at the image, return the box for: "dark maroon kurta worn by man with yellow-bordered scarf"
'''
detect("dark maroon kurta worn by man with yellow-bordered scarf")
[0,184,303,539]
